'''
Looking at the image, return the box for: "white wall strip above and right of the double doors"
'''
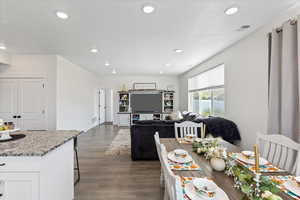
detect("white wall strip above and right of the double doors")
[0,55,56,130]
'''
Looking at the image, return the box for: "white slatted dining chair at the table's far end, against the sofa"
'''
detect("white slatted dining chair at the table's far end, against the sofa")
[174,121,205,139]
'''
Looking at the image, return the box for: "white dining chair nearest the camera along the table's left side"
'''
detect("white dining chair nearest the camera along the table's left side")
[161,144,183,200]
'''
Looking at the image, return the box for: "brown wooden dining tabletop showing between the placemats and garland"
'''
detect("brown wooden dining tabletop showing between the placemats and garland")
[160,138,293,200]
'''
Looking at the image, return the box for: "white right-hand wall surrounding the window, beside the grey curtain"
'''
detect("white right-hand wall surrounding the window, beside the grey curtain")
[180,4,300,149]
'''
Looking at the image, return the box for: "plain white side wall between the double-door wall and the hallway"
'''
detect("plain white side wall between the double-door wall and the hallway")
[56,56,99,130]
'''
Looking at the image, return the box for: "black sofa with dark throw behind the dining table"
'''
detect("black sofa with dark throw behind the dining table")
[130,113,241,161]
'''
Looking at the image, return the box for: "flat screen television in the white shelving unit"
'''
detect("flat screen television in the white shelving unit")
[130,93,162,113]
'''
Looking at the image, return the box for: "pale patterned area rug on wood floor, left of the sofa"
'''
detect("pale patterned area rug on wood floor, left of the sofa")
[105,129,131,156]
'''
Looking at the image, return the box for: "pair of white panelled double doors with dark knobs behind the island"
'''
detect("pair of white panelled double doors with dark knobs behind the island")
[0,79,46,130]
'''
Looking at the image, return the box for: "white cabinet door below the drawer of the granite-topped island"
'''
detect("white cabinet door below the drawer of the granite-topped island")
[0,173,39,200]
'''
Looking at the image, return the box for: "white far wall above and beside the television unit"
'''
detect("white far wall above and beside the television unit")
[100,74,179,124]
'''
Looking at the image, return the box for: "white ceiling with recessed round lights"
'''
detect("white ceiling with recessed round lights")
[0,0,298,74]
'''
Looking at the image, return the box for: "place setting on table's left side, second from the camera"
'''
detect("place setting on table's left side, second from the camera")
[168,149,201,171]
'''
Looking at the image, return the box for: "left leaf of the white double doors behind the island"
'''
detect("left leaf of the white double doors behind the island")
[0,79,18,126]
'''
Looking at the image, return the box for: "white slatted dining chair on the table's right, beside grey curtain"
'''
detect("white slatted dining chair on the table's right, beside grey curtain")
[256,133,300,176]
